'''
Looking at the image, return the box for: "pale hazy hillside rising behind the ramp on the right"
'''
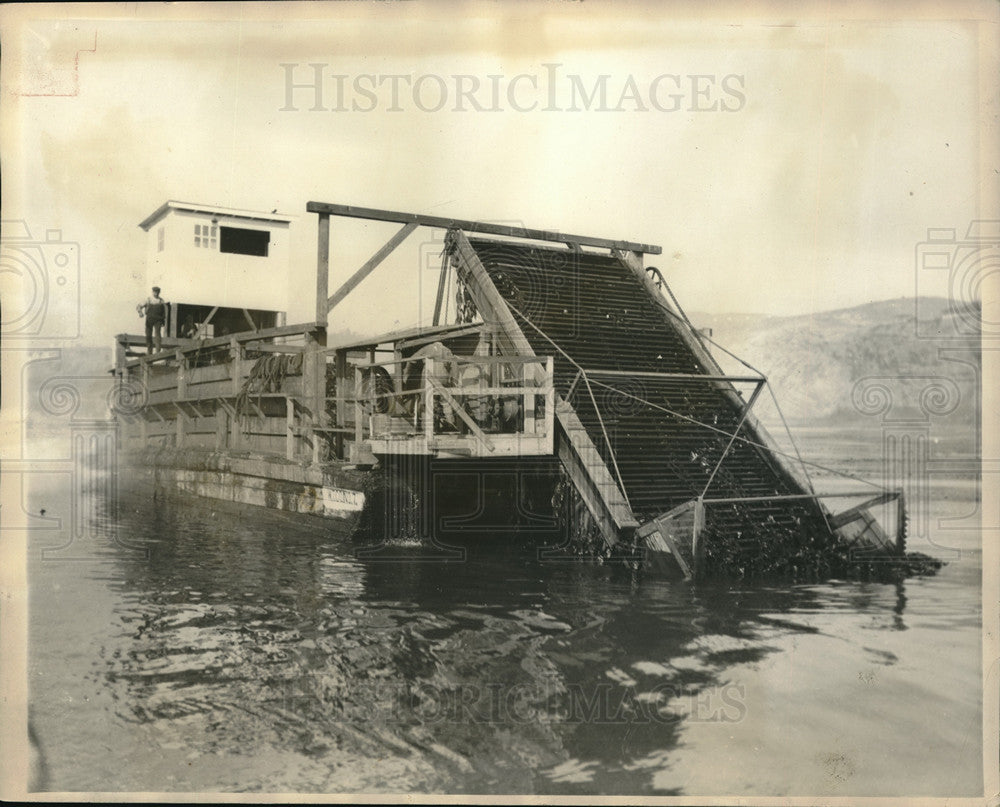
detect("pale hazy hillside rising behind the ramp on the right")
[688,297,980,424]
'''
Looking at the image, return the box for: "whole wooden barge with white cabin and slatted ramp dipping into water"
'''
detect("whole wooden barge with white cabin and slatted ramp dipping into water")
[115,202,906,578]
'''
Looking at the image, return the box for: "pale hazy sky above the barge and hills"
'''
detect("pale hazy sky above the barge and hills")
[2,0,996,343]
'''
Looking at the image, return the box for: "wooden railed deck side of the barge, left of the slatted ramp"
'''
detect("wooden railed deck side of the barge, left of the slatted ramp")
[115,323,555,464]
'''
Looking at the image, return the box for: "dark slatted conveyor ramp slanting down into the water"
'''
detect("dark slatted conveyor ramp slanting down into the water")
[449,231,900,566]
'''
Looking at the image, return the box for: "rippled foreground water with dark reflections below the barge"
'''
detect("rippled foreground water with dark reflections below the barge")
[30,474,981,795]
